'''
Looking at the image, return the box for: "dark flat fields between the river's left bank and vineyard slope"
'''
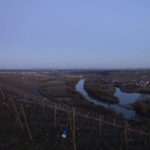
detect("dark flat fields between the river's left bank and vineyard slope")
[40,78,123,118]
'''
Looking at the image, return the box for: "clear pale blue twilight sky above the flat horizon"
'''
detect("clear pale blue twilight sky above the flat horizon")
[0,0,150,69]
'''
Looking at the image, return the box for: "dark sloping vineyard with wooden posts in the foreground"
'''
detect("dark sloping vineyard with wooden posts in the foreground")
[0,89,150,150]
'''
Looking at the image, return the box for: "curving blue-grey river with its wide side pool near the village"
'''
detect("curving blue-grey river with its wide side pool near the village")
[76,79,149,120]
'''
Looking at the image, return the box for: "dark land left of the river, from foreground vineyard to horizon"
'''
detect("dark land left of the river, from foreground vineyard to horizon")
[0,71,150,150]
